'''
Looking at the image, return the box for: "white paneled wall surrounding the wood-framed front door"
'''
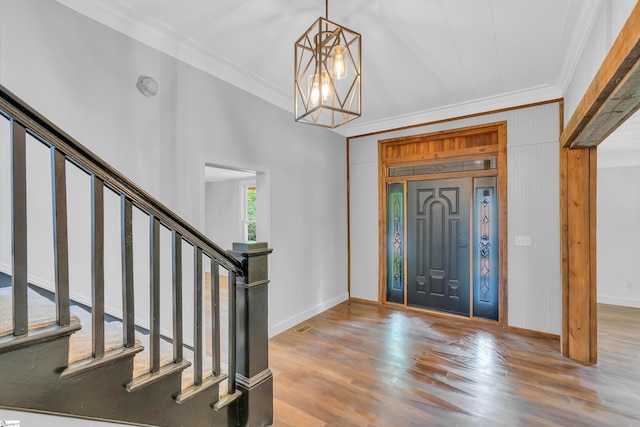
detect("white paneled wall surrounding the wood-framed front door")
[349,103,562,334]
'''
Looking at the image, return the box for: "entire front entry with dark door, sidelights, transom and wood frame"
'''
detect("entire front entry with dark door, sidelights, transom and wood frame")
[379,123,507,324]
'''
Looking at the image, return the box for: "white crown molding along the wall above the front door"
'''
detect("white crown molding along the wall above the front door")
[335,85,562,137]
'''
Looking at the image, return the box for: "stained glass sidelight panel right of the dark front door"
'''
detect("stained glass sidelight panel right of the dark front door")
[473,177,499,320]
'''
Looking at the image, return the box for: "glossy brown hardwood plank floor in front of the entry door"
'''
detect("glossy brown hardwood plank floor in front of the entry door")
[269,302,640,427]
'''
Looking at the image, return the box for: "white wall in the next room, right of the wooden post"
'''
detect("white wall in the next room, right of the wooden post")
[597,165,640,308]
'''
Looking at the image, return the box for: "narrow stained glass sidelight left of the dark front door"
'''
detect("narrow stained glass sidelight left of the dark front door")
[387,183,404,303]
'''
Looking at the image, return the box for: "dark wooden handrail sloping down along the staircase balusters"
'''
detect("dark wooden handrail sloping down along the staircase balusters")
[0,85,243,276]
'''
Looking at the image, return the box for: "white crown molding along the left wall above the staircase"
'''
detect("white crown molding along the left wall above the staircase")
[56,0,293,111]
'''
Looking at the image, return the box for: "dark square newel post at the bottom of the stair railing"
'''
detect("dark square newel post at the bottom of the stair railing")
[229,242,273,427]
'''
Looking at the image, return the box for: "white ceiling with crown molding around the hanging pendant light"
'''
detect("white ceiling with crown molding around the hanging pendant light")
[58,0,601,135]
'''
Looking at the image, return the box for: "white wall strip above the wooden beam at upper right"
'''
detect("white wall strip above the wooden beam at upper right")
[564,0,636,124]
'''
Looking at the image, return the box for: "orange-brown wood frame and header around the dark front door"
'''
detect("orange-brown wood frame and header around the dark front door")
[378,121,508,326]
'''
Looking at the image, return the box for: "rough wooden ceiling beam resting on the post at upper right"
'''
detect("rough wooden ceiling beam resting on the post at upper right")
[560,2,640,148]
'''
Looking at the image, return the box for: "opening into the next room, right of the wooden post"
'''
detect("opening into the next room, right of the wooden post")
[595,112,640,369]
